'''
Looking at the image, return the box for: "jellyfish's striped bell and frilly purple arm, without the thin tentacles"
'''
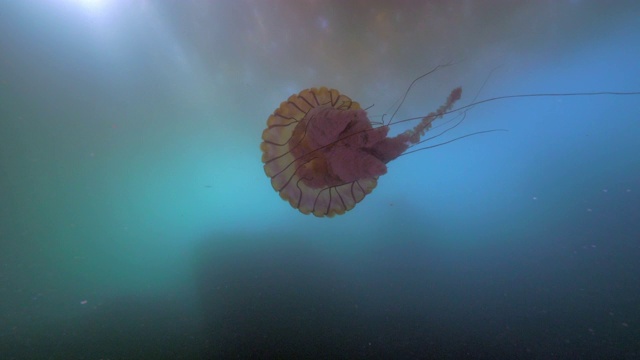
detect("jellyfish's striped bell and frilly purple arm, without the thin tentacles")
[260,87,462,217]
